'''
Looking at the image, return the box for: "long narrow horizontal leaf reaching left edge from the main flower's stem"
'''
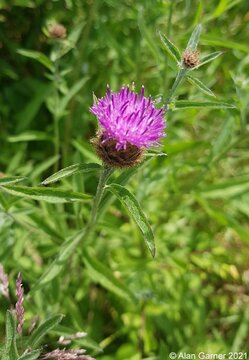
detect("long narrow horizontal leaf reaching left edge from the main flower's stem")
[1,186,91,203]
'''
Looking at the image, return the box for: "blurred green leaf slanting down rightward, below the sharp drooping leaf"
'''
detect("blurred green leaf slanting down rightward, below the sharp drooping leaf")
[83,250,134,301]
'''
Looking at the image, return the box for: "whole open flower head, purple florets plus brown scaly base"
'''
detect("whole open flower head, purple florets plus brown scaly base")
[90,86,166,167]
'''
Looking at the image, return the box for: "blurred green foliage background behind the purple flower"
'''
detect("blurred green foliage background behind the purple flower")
[0,0,249,360]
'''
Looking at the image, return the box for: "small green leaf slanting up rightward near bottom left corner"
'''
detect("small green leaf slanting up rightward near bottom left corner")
[28,314,63,349]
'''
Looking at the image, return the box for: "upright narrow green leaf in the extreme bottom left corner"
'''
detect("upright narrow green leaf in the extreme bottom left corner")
[2,310,18,360]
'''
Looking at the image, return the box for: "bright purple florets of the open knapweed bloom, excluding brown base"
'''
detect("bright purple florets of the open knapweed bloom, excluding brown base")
[90,86,165,150]
